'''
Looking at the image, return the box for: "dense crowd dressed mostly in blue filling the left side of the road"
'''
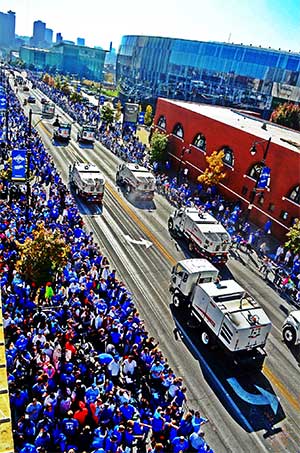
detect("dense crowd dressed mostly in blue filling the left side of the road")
[0,72,218,453]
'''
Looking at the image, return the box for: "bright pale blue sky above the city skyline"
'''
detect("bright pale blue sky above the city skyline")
[0,0,300,52]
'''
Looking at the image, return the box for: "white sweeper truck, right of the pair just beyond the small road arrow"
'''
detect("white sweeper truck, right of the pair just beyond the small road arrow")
[116,163,156,200]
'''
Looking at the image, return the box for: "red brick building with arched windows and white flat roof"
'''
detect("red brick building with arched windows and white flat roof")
[154,99,300,239]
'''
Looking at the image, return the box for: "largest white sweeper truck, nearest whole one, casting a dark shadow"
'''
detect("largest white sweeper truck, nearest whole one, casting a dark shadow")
[170,258,271,368]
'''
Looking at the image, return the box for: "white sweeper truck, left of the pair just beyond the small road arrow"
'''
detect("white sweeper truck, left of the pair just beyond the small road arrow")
[69,162,105,202]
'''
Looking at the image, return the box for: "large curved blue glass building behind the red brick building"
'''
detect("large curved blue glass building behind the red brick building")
[117,36,300,107]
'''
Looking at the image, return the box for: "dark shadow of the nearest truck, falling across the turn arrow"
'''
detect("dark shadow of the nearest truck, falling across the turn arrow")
[170,304,286,437]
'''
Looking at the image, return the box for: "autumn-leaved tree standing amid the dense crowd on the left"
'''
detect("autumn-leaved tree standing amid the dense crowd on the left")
[16,222,70,286]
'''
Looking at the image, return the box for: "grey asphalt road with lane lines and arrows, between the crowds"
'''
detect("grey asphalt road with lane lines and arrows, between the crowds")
[15,81,300,453]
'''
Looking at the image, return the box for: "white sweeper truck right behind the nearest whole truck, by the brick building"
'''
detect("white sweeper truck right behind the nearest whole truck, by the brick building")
[168,207,231,264]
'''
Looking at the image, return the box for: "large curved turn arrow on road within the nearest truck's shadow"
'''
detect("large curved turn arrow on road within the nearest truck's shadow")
[227,378,279,415]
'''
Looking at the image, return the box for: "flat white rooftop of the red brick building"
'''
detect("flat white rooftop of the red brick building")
[164,99,300,153]
